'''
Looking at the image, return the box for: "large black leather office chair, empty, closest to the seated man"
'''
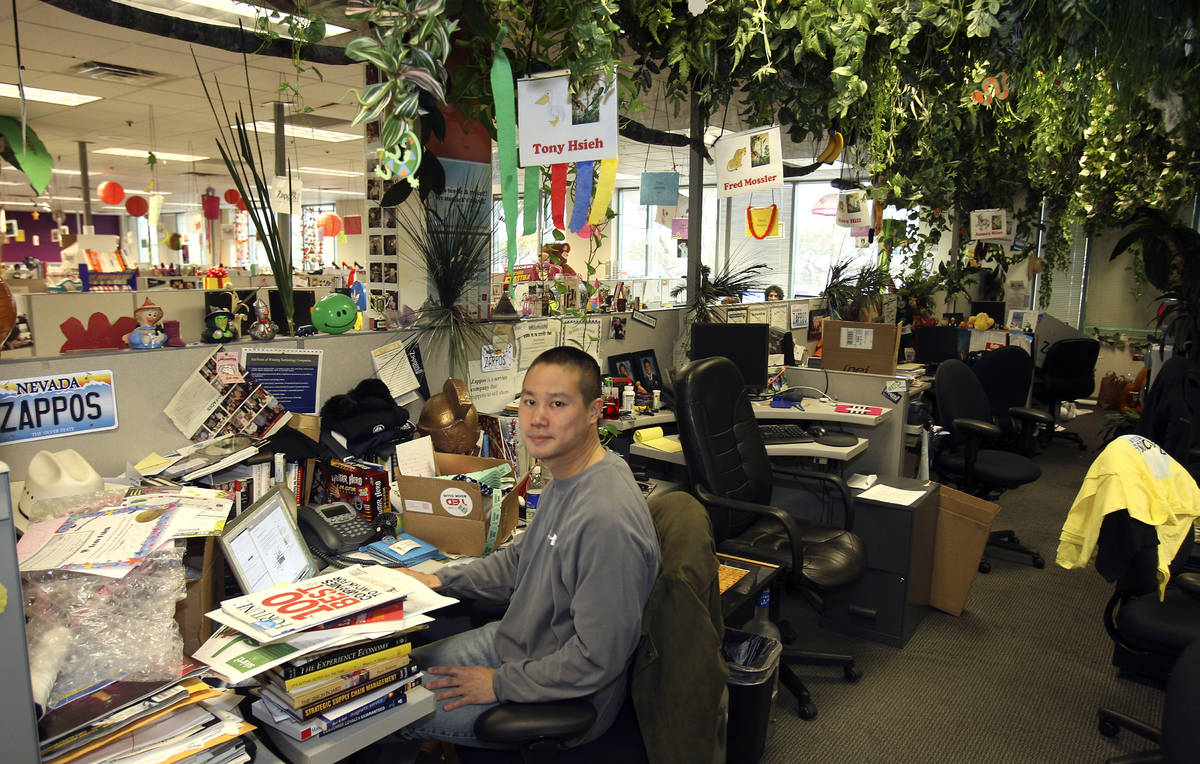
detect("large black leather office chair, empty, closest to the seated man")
[676,356,866,720]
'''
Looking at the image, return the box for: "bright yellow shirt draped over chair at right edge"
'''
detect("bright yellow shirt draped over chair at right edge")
[1057,435,1200,597]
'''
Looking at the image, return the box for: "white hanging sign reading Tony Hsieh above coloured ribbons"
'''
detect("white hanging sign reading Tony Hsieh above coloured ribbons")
[517,72,617,167]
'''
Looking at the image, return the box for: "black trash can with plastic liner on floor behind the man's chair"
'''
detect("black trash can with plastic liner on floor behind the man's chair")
[721,628,784,764]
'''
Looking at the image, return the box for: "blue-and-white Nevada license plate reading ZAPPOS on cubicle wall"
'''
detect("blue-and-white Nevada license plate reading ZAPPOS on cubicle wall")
[0,371,116,444]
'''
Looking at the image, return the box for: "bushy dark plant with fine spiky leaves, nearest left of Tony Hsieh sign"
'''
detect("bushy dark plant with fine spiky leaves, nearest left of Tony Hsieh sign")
[398,194,492,375]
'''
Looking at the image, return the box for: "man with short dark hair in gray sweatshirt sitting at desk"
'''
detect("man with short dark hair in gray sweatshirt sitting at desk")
[396,347,659,746]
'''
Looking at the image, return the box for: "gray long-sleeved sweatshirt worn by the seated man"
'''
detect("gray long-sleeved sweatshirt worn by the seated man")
[438,452,659,742]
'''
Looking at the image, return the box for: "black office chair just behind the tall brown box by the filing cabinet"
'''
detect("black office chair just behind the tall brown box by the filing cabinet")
[934,360,1045,573]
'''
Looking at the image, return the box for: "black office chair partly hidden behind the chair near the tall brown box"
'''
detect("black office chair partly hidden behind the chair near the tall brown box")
[971,345,1054,456]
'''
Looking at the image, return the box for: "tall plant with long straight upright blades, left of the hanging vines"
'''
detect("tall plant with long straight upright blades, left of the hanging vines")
[192,50,295,335]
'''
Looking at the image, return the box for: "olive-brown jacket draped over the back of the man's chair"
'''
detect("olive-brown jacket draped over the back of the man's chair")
[630,492,730,762]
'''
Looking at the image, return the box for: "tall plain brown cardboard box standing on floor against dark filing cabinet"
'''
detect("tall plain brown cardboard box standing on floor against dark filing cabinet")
[929,486,1000,615]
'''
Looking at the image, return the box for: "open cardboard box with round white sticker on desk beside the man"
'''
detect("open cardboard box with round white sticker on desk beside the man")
[395,452,517,557]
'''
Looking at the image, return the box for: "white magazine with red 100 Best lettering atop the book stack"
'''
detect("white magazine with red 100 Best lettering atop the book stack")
[213,565,420,643]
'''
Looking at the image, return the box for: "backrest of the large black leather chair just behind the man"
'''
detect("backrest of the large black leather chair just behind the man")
[674,356,772,542]
